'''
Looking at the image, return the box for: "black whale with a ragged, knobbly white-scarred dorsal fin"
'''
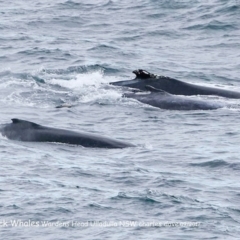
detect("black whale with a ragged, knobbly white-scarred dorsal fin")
[110,69,240,99]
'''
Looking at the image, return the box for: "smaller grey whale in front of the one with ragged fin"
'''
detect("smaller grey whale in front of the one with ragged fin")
[123,85,223,110]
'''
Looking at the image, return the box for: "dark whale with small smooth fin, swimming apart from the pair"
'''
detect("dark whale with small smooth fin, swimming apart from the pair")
[0,118,134,148]
